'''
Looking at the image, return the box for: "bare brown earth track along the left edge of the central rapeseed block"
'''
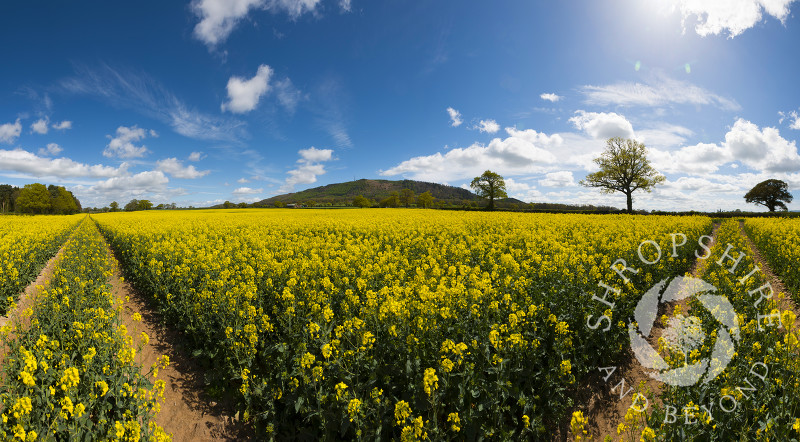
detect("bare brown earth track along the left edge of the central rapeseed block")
[101,226,252,442]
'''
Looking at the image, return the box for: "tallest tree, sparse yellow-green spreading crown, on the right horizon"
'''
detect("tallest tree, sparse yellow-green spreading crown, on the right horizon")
[580,137,666,212]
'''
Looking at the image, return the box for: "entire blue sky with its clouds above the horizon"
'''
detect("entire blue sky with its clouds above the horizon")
[0,0,800,210]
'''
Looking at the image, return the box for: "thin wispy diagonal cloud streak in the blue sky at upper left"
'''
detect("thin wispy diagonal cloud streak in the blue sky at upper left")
[60,64,247,142]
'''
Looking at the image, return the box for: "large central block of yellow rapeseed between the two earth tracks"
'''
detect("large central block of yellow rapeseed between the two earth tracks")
[95,210,711,440]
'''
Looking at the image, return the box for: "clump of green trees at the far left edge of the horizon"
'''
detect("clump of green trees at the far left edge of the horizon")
[0,183,81,215]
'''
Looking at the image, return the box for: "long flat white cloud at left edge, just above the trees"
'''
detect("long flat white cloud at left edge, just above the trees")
[0,149,128,178]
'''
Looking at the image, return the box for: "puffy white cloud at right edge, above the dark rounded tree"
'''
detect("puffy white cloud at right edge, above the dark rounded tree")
[725,118,800,172]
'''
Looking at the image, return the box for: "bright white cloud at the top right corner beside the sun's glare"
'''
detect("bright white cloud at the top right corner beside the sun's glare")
[672,0,794,38]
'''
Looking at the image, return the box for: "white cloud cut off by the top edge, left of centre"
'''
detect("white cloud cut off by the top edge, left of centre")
[192,0,324,46]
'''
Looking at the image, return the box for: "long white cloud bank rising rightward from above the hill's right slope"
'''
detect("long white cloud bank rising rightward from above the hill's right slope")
[381,128,563,182]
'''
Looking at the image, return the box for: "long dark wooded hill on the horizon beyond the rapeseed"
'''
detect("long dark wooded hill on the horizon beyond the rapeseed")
[256,179,478,206]
